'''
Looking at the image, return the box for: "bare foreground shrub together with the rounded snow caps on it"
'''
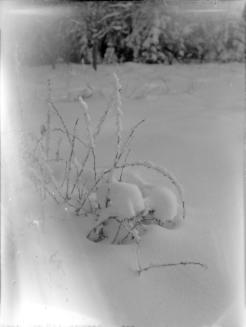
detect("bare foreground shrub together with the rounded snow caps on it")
[25,74,185,244]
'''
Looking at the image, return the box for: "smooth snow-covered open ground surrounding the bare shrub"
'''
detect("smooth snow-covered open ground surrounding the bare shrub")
[2,63,244,327]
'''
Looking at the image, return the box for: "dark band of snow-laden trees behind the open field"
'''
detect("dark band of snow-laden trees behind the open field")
[18,0,245,69]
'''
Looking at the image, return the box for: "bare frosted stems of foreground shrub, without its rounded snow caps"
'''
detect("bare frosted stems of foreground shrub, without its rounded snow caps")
[26,74,185,244]
